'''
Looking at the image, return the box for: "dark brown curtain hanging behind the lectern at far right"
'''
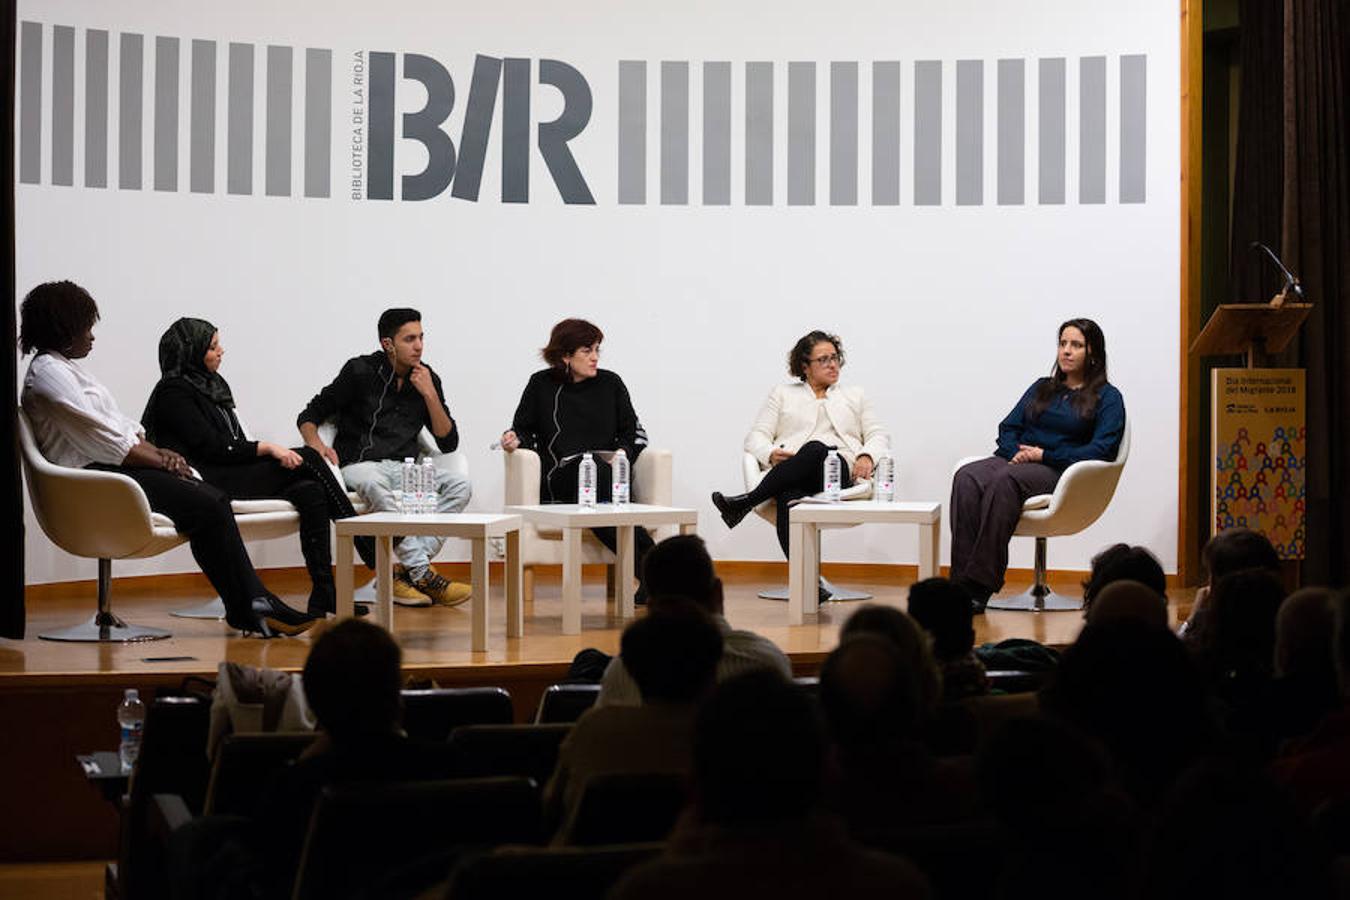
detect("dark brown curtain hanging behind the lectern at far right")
[1231,0,1350,586]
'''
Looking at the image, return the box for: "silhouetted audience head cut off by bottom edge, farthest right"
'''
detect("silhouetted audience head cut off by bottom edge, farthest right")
[1143,760,1331,900]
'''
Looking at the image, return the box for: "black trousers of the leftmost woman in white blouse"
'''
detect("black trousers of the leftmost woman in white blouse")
[88,463,271,623]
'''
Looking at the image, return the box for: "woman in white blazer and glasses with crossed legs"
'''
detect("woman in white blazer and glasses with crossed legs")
[713,331,891,556]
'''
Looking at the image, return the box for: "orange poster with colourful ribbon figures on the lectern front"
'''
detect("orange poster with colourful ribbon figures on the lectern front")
[1210,368,1308,560]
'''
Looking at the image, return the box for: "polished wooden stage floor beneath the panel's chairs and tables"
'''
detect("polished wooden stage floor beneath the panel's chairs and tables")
[0,564,1193,690]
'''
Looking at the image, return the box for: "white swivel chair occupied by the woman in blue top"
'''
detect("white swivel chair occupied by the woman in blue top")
[952,420,1130,613]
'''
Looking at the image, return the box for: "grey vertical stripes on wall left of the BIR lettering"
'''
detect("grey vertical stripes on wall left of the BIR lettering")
[18,22,332,197]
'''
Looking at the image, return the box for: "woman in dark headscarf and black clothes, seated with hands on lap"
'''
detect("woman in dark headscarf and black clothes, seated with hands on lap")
[142,318,367,615]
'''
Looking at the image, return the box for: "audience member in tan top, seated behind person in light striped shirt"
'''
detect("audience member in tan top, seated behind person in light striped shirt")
[544,609,723,838]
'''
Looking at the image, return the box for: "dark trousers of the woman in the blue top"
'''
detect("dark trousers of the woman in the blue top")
[948,456,1060,594]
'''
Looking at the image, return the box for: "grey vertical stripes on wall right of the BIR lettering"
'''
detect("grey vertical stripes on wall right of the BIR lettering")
[618,54,1148,206]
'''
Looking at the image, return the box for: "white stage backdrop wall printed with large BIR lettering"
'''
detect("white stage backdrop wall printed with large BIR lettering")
[15,0,1180,582]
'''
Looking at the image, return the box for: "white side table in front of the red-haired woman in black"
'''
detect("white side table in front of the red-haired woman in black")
[506,503,698,634]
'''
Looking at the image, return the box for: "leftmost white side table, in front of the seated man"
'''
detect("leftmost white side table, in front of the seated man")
[333,513,524,653]
